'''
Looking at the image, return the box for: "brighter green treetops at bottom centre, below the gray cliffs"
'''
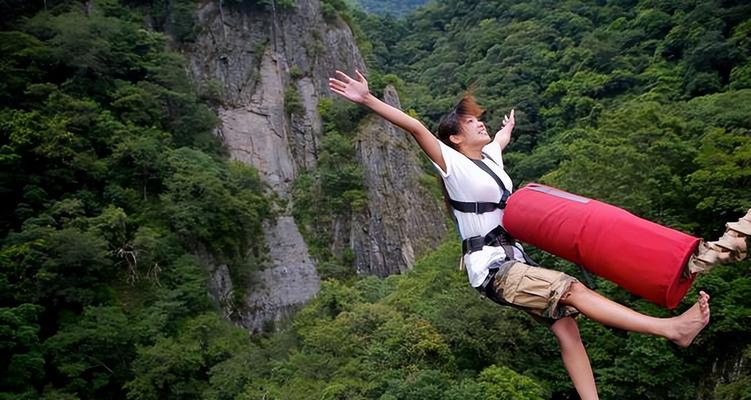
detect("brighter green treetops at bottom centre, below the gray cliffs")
[209,244,548,400]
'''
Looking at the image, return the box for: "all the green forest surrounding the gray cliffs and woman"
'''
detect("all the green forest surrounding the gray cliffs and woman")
[0,0,751,400]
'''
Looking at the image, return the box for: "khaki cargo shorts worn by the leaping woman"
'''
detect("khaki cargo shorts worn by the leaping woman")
[484,261,579,323]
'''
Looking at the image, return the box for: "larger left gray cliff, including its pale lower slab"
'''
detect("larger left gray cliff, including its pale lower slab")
[189,0,364,330]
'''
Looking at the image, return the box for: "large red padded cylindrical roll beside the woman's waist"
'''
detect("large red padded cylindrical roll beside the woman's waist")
[503,183,699,308]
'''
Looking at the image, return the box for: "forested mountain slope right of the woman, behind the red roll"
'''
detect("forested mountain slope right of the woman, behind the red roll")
[352,0,751,399]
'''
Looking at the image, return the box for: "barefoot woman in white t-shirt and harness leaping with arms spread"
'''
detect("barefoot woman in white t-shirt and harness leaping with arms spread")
[329,71,724,399]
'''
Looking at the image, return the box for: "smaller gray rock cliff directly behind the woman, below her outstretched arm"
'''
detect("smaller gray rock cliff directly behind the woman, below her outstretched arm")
[351,86,448,276]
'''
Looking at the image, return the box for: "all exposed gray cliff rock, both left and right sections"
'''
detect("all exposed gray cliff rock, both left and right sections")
[189,0,445,330]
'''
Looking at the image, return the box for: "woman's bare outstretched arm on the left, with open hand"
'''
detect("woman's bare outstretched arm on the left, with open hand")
[329,71,446,172]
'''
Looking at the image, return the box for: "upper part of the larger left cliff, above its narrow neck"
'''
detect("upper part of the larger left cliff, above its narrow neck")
[190,0,364,196]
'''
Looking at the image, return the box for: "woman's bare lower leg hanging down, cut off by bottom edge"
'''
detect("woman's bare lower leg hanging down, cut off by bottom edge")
[550,317,599,400]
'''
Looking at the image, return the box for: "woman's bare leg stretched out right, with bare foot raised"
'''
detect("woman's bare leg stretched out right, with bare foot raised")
[560,282,709,347]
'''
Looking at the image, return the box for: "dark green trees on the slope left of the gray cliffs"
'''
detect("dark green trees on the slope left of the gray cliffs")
[0,0,269,399]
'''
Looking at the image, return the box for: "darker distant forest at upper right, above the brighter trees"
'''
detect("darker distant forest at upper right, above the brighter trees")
[358,0,749,153]
